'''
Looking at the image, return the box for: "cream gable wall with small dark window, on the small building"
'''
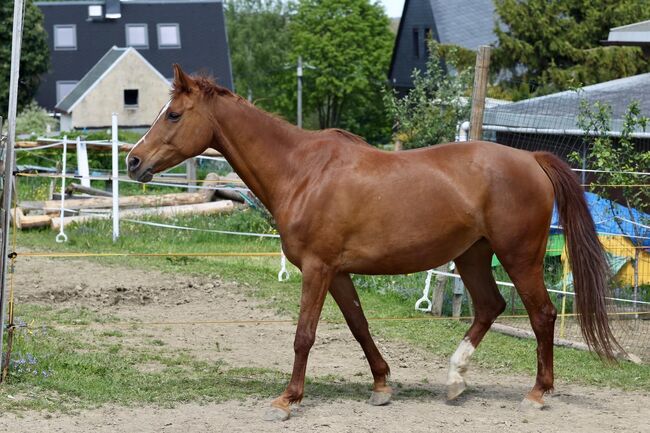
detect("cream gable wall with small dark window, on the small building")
[72,52,170,129]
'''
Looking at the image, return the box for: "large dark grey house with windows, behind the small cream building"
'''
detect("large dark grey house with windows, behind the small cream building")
[36,0,233,111]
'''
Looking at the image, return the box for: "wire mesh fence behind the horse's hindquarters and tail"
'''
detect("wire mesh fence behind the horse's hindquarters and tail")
[483,74,650,361]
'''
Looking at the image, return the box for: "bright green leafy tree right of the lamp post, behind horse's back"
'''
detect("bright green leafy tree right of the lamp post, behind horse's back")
[289,0,394,141]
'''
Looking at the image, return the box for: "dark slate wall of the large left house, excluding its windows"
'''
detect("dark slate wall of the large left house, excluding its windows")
[36,1,232,110]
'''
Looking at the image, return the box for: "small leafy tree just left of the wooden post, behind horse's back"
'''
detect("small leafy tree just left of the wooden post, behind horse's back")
[384,41,473,149]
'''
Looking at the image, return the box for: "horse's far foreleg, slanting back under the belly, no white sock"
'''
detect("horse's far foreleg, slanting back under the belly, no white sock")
[330,274,392,406]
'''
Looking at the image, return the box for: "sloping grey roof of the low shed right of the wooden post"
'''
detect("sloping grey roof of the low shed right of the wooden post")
[483,73,650,131]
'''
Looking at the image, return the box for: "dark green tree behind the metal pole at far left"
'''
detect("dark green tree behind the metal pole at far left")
[0,0,50,117]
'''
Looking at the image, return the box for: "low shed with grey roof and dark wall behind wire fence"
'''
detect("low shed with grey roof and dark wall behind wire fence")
[483,73,650,157]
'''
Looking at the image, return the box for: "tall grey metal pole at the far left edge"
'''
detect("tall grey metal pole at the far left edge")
[0,0,24,381]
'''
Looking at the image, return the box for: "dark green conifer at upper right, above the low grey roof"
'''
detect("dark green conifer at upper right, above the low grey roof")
[494,0,650,97]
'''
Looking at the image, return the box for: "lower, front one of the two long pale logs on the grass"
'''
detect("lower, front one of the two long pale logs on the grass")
[50,200,235,230]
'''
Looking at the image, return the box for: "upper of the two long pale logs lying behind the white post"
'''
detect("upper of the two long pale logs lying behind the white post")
[20,192,205,212]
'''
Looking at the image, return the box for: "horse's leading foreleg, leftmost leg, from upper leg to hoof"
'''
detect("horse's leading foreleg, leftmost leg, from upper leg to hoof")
[265,261,335,421]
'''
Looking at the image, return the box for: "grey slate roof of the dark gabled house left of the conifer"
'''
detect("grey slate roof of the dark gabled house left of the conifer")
[428,0,497,50]
